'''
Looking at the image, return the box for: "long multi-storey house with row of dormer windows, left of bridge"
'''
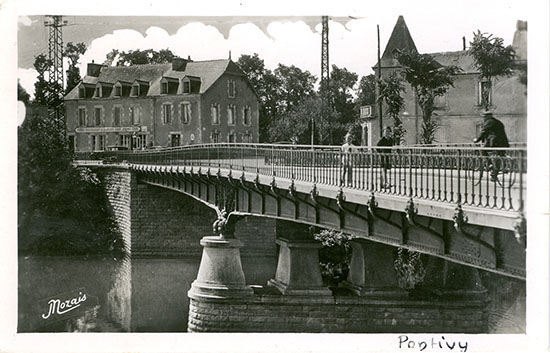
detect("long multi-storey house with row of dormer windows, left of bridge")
[65,58,259,152]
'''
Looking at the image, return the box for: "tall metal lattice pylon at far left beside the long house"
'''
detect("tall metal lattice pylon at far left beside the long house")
[44,16,67,136]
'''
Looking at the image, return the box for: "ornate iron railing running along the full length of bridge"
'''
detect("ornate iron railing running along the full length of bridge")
[75,143,527,211]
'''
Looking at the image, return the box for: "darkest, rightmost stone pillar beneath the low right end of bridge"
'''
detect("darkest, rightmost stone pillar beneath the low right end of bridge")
[422,256,487,300]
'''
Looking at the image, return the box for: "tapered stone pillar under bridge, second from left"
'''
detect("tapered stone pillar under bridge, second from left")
[267,239,332,296]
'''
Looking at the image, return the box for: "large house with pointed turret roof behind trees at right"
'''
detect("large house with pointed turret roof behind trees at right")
[363,16,527,144]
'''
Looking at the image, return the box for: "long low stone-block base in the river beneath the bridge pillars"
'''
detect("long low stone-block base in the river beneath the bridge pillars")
[188,294,488,333]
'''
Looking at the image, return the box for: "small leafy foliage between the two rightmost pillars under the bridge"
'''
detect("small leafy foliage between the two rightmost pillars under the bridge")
[394,248,426,289]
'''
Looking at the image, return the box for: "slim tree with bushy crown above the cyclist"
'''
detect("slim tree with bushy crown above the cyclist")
[469,30,515,109]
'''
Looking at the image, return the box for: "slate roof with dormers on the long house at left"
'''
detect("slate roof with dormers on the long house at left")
[65,59,240,99]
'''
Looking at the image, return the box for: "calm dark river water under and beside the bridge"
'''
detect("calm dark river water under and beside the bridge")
[18,256,525,333]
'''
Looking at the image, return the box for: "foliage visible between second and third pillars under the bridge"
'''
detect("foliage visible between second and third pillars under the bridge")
[314,229,353,286]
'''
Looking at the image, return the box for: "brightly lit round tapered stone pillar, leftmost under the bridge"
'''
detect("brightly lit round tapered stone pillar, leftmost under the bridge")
[187,236,253,301]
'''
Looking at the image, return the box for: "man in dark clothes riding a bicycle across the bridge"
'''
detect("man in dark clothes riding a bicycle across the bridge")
[474,110,510,181]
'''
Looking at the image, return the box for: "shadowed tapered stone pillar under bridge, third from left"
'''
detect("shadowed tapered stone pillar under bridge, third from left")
[343,239,407,297]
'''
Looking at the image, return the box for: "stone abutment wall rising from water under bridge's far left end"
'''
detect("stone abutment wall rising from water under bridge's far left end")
[100,168,280,258]
